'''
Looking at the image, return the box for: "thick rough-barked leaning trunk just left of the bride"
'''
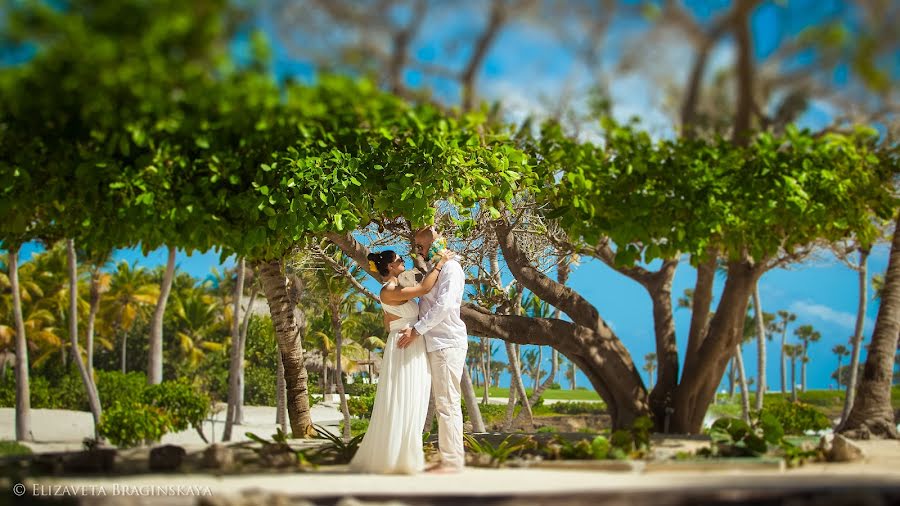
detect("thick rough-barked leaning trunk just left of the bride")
[258,260,316,438]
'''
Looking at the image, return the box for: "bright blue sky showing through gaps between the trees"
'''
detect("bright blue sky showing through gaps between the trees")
[5,0,888,394]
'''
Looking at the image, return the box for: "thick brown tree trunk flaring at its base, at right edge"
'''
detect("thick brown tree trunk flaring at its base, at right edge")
[840,216,900,439]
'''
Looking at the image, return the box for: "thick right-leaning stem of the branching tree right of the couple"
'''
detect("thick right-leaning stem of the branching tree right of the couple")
[671,260,764,434]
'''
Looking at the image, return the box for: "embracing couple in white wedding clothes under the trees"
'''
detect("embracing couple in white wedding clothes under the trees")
[350,227,468,474]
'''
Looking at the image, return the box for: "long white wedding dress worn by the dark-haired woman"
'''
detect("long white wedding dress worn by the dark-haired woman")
[350,292,431,474]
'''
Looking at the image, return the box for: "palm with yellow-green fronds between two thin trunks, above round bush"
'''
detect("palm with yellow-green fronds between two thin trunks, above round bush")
[101,260,159,373]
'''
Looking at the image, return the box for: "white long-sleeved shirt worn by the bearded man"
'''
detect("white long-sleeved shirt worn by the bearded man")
[414,260,469,352]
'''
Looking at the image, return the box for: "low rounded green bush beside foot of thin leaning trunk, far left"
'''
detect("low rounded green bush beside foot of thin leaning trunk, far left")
[97,401,171,448]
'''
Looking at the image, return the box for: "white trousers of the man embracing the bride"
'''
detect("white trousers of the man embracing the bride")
[428,348,466,469]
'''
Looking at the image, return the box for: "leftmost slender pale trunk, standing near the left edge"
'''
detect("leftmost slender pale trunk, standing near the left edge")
[9,244,34,441]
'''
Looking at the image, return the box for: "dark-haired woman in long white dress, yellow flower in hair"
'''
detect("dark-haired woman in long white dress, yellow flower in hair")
[350,250,454,474]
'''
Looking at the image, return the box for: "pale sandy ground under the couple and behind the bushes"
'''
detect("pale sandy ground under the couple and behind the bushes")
[0,404,900,504]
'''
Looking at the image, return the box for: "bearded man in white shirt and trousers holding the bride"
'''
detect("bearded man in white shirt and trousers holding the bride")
[397,227,469,472]
